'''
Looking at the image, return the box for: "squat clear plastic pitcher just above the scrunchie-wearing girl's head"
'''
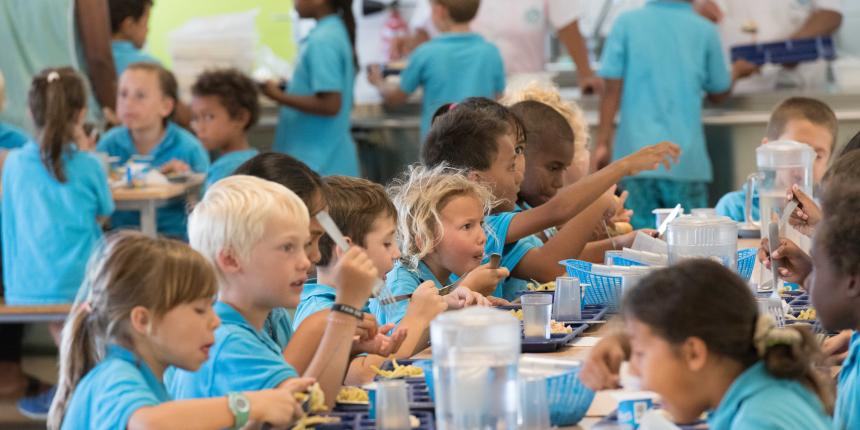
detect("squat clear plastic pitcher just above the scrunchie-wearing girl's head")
[666,215,738,270]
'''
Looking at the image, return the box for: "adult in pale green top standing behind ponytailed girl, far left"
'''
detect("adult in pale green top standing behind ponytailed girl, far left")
[0,0,116,418]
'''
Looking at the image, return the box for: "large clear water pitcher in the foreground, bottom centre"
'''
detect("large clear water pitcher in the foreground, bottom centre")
[430,307,520,430]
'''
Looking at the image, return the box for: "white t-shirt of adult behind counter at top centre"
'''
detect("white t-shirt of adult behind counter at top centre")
[410,0,583,75]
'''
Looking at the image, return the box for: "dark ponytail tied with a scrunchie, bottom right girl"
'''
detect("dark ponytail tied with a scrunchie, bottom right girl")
[754,314,835,415]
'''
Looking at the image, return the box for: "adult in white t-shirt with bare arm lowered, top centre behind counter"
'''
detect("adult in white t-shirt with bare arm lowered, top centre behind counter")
[410,0,603,92]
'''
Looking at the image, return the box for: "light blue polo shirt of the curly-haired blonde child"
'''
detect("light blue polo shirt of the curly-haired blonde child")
[369,261,444,325]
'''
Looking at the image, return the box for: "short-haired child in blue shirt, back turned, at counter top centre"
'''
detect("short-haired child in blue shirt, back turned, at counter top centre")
[368,0,505,139]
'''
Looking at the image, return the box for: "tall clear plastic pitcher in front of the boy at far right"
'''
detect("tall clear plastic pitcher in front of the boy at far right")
[744,140,815,237]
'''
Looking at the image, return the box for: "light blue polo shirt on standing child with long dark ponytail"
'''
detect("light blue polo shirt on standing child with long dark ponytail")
[273,14,361,176]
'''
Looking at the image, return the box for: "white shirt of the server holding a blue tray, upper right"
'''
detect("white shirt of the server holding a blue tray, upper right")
[715,0,842,92]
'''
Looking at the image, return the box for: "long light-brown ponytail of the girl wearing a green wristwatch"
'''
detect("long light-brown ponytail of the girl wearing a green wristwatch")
[48,305,104,430]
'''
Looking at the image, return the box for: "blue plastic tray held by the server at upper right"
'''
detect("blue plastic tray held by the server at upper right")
[731,36,836,65]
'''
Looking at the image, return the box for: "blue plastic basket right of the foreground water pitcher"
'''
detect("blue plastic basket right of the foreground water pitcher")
[546,367,594,427]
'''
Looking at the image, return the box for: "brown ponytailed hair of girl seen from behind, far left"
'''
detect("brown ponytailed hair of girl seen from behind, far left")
[28,67,86,182]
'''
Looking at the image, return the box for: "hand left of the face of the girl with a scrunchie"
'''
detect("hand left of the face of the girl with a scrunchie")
[579,334,628,391]
